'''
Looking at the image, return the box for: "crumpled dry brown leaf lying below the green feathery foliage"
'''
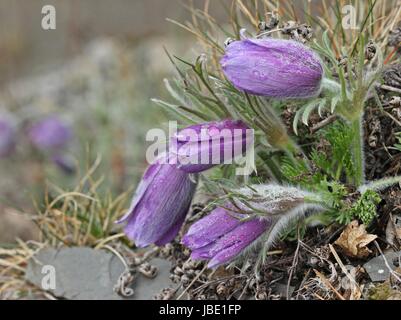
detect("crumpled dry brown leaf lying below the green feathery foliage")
[334,220,377,258]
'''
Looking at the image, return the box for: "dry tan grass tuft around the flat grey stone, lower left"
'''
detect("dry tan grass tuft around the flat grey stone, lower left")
[0,158,130,299]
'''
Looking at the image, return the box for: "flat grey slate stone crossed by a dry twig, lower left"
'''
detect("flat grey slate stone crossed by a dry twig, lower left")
[26,247,172,300]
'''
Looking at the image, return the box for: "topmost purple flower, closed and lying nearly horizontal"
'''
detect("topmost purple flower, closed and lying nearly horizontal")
[220,38,323,99]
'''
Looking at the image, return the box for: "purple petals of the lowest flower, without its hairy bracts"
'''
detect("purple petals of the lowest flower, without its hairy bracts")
[182,208,271,268]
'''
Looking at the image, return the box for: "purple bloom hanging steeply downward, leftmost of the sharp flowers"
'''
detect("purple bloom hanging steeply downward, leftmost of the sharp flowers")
[117,158,196,247]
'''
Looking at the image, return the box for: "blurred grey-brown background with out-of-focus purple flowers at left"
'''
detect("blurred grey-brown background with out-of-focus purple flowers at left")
[0,0,223,243]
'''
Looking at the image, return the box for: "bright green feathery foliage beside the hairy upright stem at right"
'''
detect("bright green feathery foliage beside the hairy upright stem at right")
[281,122,380,225]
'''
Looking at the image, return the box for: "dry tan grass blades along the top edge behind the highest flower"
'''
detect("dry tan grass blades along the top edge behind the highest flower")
[170,0,401,70]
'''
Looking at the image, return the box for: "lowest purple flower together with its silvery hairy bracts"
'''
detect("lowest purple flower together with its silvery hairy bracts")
[182,184,319,268]
